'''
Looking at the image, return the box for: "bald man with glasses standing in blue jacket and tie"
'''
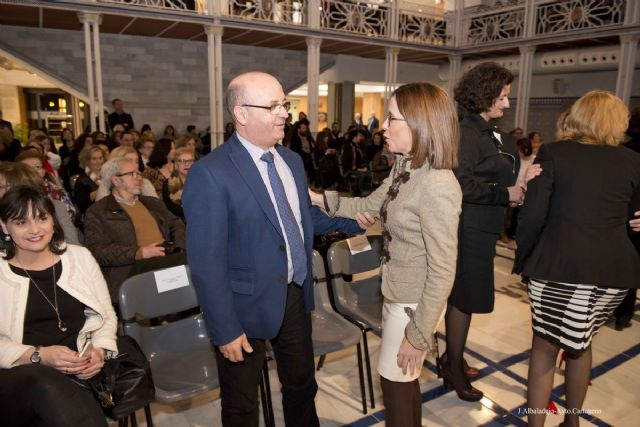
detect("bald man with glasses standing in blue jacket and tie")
[182,72,361,427]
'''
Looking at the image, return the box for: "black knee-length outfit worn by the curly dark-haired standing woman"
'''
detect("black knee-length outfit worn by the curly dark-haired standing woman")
[449,114,518,313]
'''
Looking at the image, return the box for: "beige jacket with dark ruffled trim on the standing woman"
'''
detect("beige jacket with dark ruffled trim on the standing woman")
[325,160,462,351]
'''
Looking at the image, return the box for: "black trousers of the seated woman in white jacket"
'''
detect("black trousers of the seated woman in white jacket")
[0,365,107,427]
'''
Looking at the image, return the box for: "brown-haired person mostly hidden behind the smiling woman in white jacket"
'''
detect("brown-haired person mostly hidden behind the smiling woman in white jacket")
[0,162,80,245]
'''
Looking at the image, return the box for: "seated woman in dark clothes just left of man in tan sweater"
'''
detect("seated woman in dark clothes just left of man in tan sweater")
[73,145,107,215]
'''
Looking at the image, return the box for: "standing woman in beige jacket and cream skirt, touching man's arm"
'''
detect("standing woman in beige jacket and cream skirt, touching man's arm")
[312,83,462,427]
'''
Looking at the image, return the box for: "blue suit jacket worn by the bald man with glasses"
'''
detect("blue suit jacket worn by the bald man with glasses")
[182,134,362,345]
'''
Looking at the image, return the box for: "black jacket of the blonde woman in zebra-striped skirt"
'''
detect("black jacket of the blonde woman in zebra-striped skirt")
[513,141,640,288]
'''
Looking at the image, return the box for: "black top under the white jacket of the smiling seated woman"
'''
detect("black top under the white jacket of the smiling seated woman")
[9,261,85,349]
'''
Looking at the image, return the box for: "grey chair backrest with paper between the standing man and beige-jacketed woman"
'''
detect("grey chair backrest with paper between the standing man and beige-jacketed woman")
[327,236,382,310]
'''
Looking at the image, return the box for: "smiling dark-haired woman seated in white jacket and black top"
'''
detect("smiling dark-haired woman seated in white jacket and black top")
[0,186,118,427]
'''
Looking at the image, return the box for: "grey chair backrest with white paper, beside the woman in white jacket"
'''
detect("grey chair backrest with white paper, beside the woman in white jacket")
[119,265,198,322]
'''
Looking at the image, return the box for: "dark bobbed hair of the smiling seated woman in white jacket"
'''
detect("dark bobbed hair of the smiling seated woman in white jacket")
[0,185,66,259]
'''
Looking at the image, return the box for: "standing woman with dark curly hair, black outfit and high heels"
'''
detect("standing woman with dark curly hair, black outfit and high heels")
[439,62,524,401]
